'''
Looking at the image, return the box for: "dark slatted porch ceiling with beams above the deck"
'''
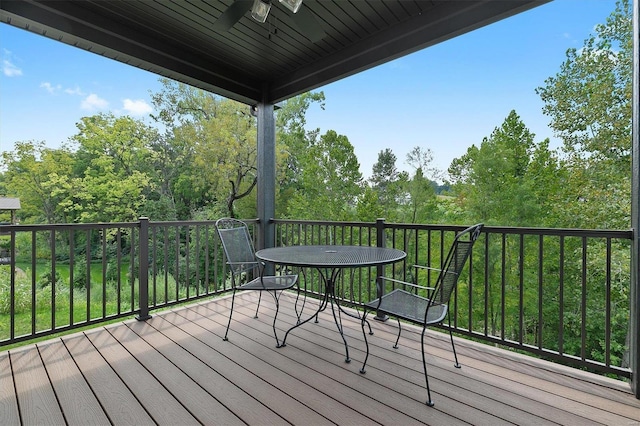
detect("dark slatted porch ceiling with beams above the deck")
[0,0,547,105]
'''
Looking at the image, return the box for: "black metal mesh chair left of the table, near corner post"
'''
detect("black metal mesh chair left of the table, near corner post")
[216,218,298,346]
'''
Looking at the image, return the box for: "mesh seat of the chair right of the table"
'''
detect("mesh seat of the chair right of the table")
[365,288,447,324]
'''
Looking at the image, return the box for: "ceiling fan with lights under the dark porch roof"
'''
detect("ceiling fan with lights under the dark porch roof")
[213,0,325,43]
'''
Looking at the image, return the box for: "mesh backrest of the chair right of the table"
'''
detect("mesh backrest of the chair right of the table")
[429,223,484,305]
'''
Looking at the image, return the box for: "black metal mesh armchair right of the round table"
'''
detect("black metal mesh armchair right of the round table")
[360,223,483,406]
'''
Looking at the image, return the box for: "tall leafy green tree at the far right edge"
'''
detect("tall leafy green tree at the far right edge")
[537,0,633,366]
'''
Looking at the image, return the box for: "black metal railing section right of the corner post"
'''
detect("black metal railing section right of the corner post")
[273,220,632,378]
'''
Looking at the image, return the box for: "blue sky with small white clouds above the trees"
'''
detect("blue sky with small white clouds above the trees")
[0,0,615,176]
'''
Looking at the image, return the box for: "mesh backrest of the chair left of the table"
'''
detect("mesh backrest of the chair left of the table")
[216,218,258,275]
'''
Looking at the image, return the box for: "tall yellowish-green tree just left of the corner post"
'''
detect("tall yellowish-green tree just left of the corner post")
[152,79,268,217]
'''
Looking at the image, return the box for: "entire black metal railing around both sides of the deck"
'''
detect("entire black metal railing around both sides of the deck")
[0,218,632,378]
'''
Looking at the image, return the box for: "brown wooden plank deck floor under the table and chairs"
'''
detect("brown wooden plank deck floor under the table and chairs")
[0,293,640,426]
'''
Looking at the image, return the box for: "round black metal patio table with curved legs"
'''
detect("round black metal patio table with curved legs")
[256,245,407,362]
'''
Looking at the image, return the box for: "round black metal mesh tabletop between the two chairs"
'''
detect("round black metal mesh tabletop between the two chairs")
[256,245,407,268]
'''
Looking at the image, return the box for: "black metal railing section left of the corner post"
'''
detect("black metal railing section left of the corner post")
[0,218,256,346]
